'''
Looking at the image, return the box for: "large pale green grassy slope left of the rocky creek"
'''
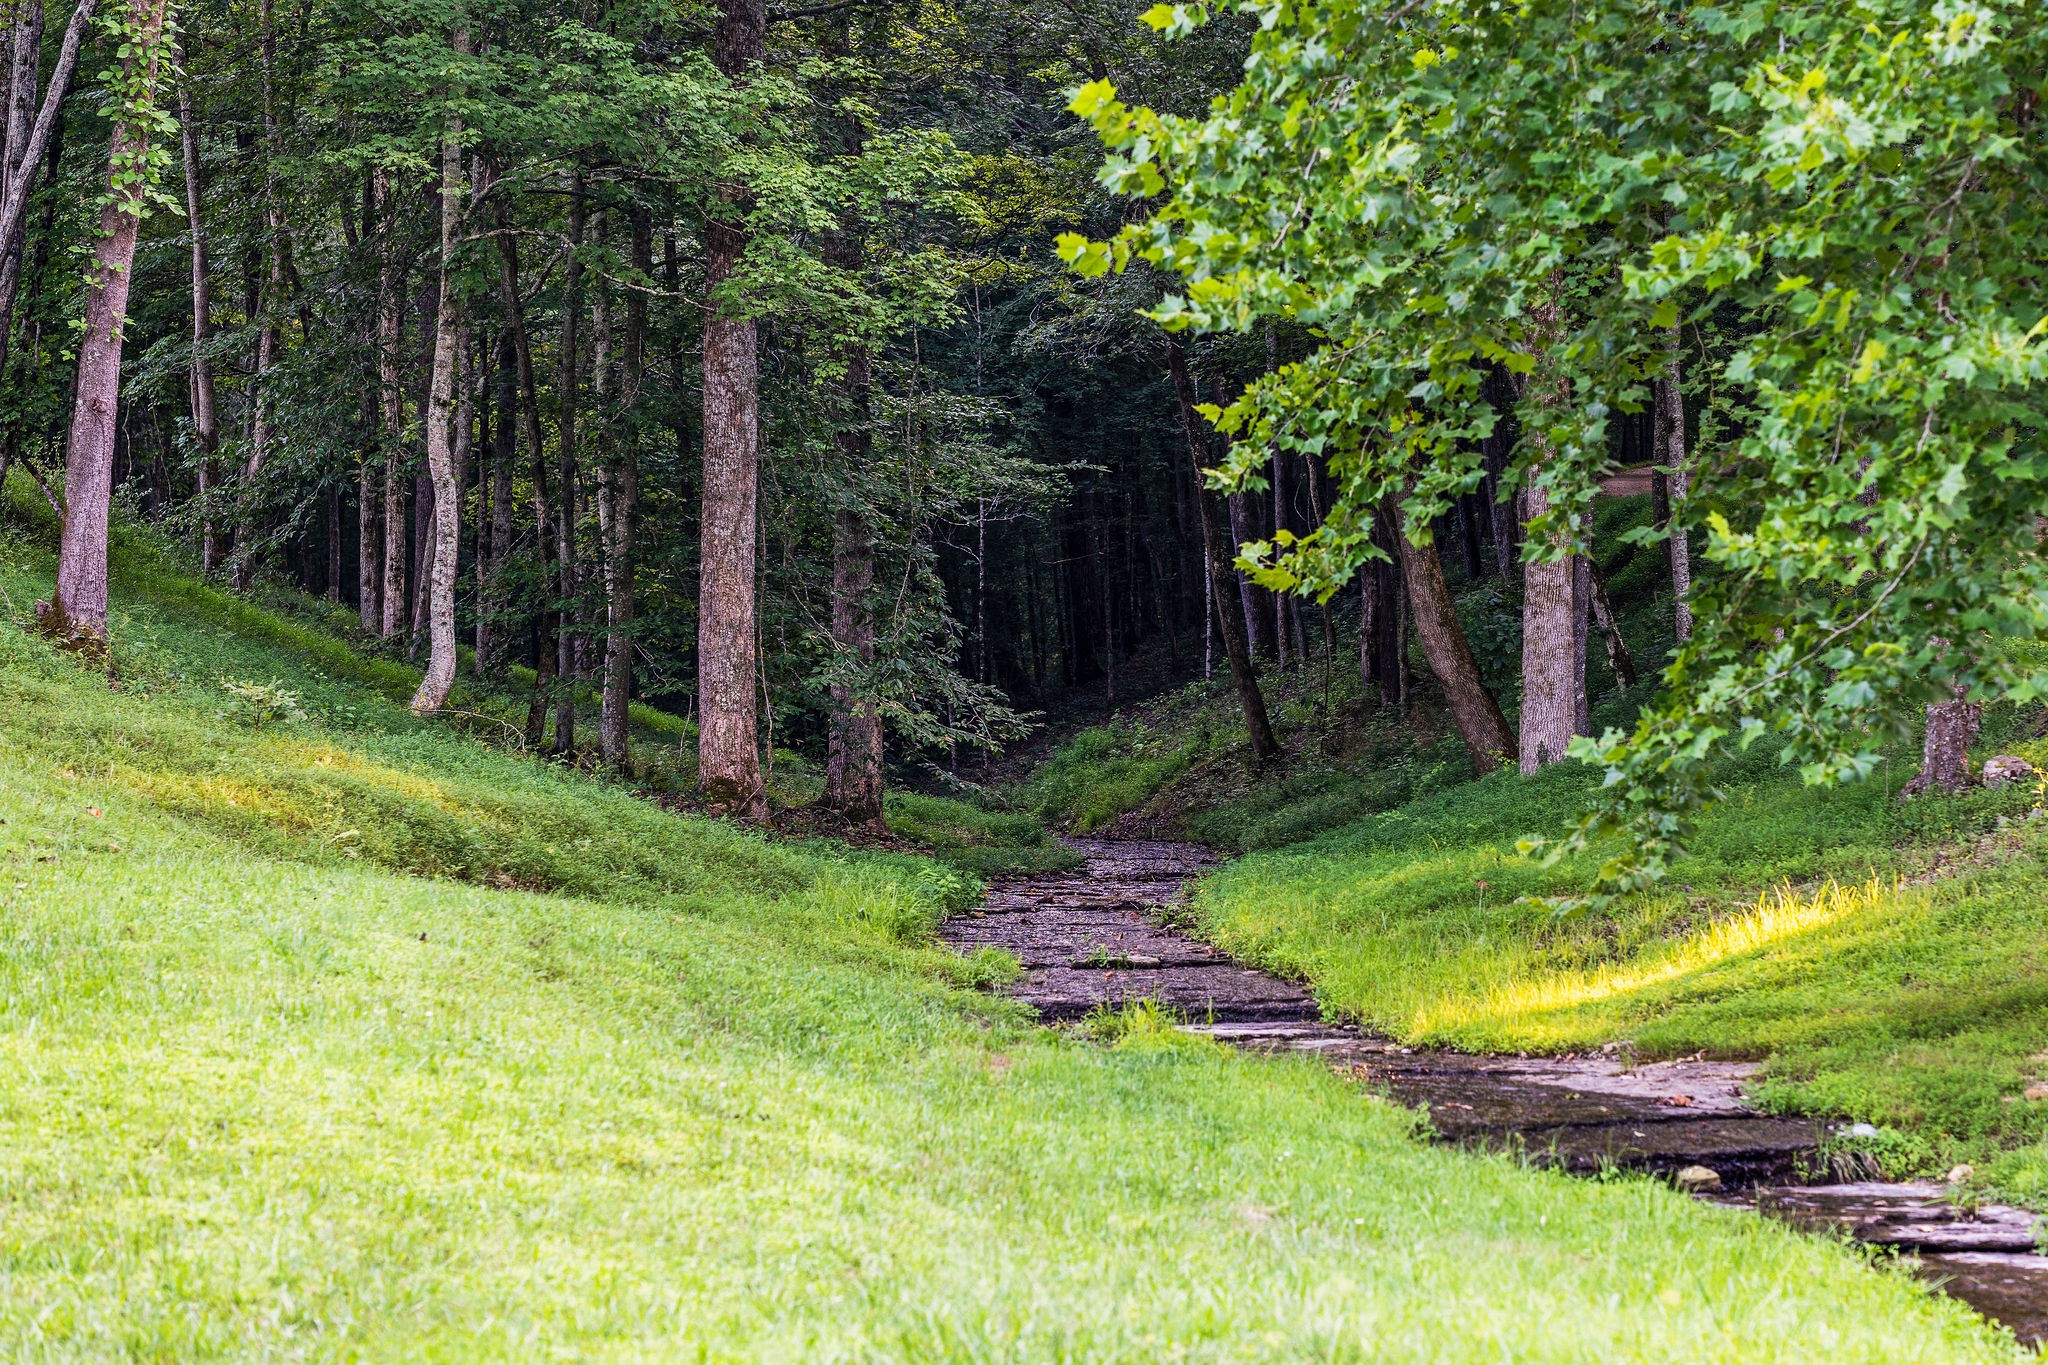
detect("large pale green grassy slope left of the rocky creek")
[0,489,2011,1361]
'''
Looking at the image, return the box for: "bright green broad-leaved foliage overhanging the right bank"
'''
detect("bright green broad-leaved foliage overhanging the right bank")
[1063,0,2048,894]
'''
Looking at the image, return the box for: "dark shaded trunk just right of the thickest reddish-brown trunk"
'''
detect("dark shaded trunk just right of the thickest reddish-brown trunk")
[823,227,889,833]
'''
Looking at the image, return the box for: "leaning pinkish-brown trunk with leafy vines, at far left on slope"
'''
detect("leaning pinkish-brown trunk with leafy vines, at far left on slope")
[37,0,170,655]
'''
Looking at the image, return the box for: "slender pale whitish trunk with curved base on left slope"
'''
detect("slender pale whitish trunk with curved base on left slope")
[412,46,469,714]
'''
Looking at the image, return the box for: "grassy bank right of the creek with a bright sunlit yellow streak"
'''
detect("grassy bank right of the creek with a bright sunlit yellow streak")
[1196,732,2048,1199]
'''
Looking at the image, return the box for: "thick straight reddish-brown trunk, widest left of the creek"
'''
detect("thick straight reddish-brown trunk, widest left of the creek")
[696,0,768,819]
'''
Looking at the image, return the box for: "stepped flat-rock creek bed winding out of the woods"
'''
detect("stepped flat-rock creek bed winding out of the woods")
[940,839,2048,1345]
